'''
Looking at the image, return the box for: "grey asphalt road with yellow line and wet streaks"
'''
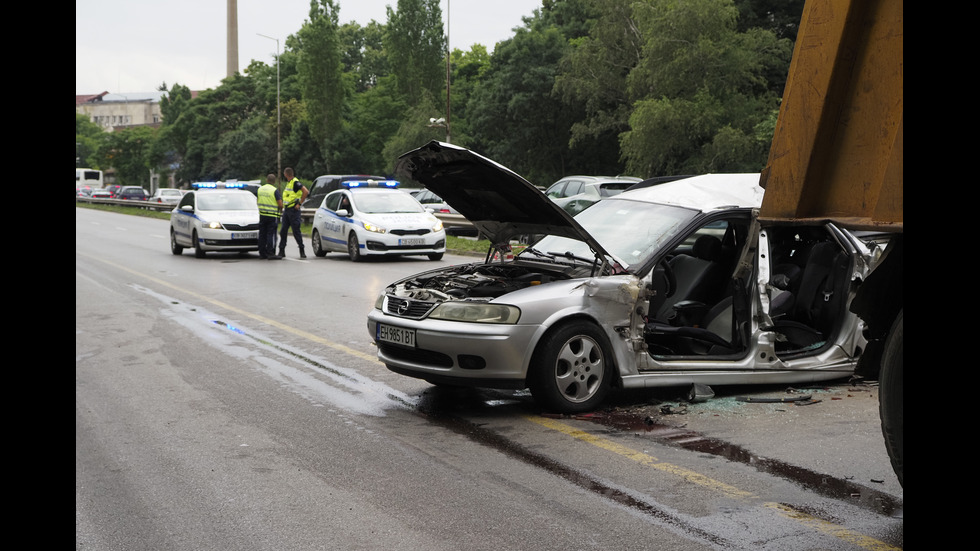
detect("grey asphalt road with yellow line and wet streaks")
[75,208,904,551]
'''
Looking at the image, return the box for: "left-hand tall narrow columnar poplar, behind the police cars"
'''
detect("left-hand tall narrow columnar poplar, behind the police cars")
[290,0,351,165]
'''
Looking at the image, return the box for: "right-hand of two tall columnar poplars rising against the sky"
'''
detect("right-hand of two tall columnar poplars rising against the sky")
[384,0,446,107]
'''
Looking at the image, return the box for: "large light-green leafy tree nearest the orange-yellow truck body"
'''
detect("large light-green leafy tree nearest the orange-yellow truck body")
[621,0,792,176]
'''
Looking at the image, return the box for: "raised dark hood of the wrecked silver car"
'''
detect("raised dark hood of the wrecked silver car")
[395,141,613,264]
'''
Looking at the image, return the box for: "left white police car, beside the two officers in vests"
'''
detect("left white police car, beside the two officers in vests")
[170,182,259,258]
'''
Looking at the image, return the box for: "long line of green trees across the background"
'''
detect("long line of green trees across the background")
[75,0,803,189]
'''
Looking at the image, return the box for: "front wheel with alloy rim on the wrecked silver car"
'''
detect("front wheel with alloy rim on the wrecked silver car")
[527,320,613,413]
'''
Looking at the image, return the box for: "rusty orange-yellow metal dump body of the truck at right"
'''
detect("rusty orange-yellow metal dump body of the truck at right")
[759,0,904,232]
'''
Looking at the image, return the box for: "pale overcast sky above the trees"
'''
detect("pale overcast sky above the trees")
[75,0,541,95]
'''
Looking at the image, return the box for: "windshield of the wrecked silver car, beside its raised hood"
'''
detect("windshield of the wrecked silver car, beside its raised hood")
[527,199,697,272]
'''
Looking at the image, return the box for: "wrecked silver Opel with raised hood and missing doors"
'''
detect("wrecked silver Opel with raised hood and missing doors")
[368,142,876,413]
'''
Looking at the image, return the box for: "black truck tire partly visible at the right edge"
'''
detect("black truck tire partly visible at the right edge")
[878,308,905,488]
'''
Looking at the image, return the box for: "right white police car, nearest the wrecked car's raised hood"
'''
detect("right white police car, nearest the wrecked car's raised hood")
[311,180,446,262]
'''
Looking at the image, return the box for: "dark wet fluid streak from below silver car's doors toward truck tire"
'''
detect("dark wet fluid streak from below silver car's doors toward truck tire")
[576,410,903,516]
